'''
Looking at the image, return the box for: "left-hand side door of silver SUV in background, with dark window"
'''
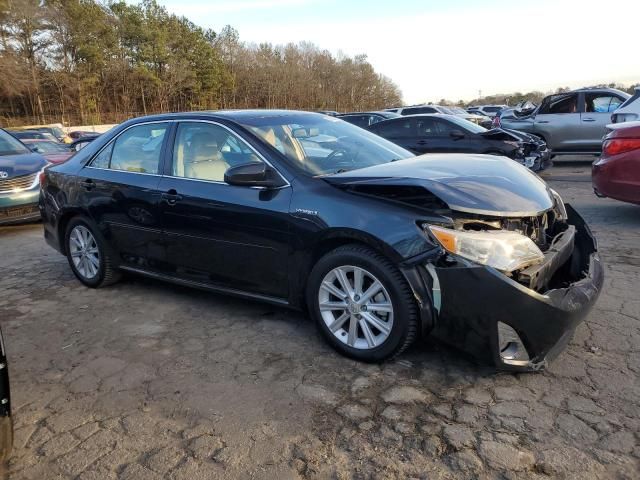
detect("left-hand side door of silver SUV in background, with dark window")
[533,92,584,151]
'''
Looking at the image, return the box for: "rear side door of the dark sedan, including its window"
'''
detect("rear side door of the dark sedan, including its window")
[78,122,171,268]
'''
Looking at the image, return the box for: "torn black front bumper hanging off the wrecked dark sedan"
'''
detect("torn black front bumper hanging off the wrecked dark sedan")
[407,205,604,371]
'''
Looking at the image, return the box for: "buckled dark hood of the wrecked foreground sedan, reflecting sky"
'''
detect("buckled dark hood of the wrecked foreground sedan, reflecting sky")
[323,154,554,217]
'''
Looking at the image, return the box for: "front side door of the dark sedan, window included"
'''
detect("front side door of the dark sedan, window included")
[159,121,291,298]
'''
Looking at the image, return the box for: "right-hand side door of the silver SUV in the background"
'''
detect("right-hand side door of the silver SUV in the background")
[580,92,625,149]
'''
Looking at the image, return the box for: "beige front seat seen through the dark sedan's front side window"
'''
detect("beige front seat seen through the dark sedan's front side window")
[184,133,229,182]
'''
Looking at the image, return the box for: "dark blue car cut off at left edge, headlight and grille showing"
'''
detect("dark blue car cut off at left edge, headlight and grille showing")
[0,129,47,225]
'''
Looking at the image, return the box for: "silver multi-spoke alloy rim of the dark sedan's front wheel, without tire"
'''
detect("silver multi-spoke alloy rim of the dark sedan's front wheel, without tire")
[318,265,393,350]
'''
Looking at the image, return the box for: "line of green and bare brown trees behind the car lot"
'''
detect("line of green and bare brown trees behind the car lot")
[0,0,401,126]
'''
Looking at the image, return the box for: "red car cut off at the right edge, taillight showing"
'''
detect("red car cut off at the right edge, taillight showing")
[591,122,640,205]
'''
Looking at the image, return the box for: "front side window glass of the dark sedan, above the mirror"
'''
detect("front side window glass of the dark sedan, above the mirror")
[172,122,260,182]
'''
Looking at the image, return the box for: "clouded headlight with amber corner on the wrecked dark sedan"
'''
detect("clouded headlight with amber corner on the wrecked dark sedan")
[426,225,544,273]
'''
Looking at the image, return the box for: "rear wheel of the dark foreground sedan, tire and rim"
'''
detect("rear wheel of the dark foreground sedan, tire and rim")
[64,217,121,288]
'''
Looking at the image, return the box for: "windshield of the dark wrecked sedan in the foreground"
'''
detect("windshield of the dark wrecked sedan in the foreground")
[242,114,414,175]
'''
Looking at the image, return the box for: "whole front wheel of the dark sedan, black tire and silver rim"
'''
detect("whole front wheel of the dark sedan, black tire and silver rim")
[306,244,418,362]
